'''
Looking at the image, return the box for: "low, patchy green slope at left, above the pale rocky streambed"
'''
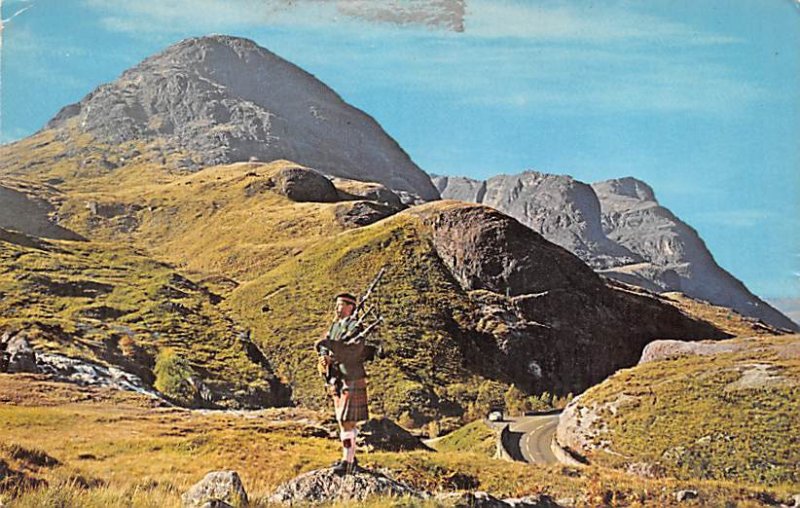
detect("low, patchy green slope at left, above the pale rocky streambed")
[0,230,280,405]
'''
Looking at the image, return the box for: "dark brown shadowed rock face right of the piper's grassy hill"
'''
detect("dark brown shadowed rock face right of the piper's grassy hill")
[404,201,729,394]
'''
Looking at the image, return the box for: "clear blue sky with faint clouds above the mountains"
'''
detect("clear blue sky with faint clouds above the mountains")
[0,0,800,316]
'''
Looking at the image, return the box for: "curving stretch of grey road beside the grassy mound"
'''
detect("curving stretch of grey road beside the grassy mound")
[503,413,561,464]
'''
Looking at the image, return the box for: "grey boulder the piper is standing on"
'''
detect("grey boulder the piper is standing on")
[269,468,418,504]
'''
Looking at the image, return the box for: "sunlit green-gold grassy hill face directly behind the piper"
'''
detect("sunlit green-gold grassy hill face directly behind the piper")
[226,206,479,421]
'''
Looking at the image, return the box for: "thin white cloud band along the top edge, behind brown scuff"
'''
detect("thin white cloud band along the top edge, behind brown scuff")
[83,0,736,45]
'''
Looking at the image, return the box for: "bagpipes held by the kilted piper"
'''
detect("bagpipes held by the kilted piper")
[317,266,386,393]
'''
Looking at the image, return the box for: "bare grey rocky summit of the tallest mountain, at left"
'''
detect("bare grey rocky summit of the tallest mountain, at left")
[46,35,439,200]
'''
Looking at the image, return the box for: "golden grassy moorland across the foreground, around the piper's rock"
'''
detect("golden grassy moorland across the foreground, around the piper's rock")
[0,374,790,508]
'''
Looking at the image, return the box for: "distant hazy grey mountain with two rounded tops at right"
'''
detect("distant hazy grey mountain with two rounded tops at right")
[433,171,799,330]
